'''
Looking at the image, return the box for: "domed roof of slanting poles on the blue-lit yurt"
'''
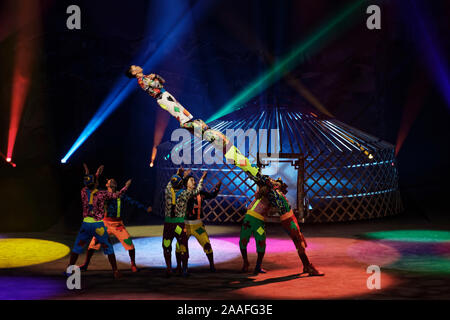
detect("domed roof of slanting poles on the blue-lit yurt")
[202,105,394,155]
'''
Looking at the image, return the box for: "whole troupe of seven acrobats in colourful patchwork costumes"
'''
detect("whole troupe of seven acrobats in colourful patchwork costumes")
[65,65,324,278]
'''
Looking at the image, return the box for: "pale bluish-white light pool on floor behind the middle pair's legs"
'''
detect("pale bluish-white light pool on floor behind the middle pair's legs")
[114,237,241,268]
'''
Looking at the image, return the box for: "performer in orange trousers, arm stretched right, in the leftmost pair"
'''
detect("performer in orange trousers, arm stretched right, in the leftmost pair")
[80,179,152,272]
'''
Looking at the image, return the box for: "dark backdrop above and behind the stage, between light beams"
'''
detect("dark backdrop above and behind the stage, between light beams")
[0,0,450,231]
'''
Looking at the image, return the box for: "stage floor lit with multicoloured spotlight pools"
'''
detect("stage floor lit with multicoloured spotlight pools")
[0,217,450,300]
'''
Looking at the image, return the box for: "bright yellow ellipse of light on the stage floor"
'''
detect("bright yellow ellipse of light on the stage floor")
[0,238,70,269]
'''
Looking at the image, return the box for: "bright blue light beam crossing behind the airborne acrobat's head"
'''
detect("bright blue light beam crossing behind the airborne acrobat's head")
[61,0,211,163]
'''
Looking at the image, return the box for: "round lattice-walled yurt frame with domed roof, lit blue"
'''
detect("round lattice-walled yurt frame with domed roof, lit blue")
[155,105,402,223]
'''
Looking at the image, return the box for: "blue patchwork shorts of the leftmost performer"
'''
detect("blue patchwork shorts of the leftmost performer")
[72,221,114,255]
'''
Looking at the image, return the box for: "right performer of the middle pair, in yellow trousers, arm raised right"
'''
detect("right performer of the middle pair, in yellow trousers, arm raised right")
[176,180,222,272]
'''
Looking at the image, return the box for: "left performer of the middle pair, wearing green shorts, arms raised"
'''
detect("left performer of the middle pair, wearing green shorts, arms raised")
[162,169,206,276]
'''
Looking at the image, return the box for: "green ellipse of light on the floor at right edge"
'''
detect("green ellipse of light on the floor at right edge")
[364,230,450,242]
